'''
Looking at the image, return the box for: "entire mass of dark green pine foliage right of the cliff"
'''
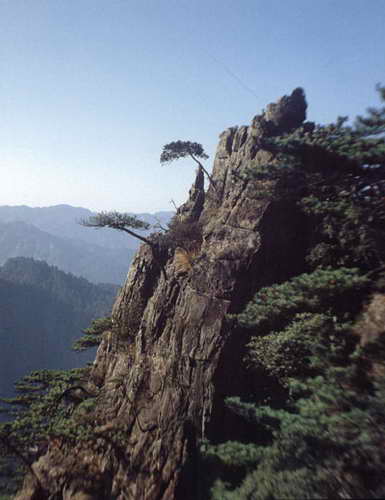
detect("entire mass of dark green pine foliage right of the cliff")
[202,88,385,500]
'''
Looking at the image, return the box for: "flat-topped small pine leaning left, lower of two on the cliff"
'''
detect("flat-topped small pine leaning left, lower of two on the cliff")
[79,211,167,279]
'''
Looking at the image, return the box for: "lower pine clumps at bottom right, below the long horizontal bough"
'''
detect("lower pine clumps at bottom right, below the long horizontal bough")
[203,280,385,500]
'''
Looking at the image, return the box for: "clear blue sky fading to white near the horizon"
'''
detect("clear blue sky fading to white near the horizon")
[0,0,385,213]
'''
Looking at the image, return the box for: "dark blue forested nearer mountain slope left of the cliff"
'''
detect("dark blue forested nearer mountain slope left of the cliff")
[0,257,118,396]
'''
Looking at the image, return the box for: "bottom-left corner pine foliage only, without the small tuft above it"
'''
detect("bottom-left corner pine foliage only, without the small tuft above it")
[0,368,91,494]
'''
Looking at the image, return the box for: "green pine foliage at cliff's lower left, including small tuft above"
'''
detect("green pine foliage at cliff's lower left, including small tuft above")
[0,310,118,494]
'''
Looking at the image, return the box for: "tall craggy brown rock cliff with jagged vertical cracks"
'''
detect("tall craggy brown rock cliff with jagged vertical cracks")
[18,89,306,500]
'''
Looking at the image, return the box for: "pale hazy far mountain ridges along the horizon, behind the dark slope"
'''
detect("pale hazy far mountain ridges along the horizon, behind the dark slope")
[0,205,174,284]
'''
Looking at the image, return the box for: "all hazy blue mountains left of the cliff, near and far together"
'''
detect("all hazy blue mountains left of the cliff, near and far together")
[0,205,173,396]
